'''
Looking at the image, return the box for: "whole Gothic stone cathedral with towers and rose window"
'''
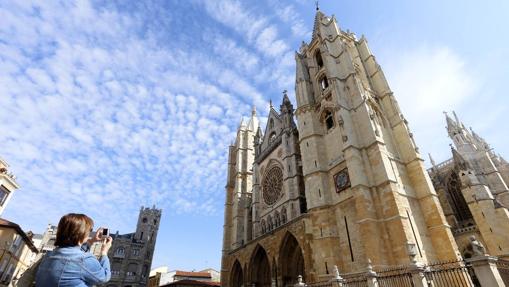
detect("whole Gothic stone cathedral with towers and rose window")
[221,6,509,286]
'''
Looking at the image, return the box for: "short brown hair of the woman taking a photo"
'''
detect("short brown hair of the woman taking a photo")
[55,213,94,247]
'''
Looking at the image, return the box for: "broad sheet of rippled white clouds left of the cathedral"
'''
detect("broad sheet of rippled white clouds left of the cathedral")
[0,0,308,237]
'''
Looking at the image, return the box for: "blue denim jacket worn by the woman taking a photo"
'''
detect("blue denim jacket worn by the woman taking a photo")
[35,246,111,287]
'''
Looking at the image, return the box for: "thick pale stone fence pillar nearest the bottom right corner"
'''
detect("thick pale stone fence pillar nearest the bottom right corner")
[466,255,505,287]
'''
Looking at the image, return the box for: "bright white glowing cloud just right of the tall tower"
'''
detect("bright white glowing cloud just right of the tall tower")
[383,46,482,164]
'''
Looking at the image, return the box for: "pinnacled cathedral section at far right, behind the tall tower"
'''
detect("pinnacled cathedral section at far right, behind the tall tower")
[428,114,509,258]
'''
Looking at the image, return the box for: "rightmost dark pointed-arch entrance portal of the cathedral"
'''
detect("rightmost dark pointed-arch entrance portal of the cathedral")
[279,232,306,287]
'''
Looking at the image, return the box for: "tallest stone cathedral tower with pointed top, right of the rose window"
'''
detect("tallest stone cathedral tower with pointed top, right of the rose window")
[295,11,459,271]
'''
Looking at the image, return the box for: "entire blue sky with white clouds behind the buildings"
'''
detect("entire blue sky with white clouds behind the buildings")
[0,0,509,270]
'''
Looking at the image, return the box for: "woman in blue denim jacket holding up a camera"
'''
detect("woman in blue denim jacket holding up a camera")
[35,213,112,287]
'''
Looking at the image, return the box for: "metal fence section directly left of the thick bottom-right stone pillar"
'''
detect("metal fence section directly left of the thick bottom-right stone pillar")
[424,260,481,287]
